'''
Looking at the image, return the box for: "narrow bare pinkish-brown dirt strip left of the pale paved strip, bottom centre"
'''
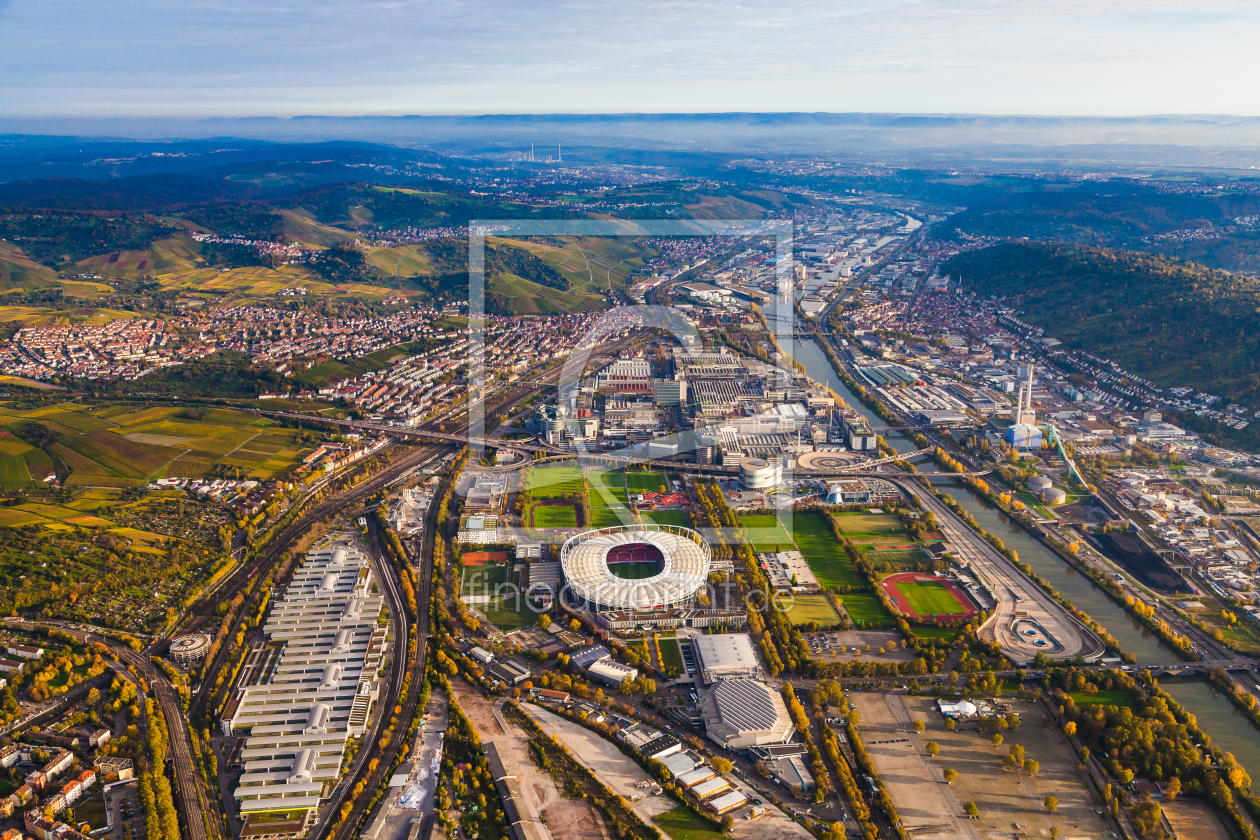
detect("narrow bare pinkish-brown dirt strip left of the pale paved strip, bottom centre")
[451,680,605,840]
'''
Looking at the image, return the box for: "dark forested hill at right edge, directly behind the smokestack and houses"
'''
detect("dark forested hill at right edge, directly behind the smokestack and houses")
[941,242,1260,404]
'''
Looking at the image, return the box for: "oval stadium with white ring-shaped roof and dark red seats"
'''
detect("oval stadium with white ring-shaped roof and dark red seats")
[559,524,712,612]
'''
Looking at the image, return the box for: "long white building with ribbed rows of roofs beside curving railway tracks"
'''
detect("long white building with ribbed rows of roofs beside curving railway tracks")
[221,543,389,827]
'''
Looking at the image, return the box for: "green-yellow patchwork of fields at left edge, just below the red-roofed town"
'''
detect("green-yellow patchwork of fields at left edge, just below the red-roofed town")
[0,403,314,490]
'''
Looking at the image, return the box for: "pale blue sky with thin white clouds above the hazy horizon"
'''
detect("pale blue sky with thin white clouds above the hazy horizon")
[0,0,1260,118]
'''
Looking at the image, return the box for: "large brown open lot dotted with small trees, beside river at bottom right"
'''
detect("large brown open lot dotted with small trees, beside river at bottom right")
[852,693,1111,840]
